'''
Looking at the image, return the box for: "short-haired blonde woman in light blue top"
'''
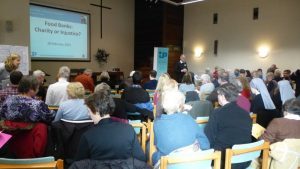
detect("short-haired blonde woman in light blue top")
[54,82,90,121]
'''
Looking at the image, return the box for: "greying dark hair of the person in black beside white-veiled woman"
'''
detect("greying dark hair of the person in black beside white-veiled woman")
[218,83,239,102]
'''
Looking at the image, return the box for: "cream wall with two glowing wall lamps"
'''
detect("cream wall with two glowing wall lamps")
[183,0,300,73]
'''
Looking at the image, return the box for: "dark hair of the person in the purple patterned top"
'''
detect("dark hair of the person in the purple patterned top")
[18,76,39,93]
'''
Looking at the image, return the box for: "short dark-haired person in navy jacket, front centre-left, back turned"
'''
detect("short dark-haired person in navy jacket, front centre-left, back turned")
[76,90,146,161]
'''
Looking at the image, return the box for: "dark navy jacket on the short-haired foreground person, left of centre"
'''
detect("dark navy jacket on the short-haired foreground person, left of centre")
[76,118,146,161]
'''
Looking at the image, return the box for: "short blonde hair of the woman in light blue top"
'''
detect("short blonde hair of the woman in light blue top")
[67,82,85,99]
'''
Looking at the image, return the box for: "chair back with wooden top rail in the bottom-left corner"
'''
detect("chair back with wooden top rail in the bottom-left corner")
[0,157,64,169]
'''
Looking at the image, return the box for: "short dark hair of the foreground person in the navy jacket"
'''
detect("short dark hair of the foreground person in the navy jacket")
[85,89,115,117]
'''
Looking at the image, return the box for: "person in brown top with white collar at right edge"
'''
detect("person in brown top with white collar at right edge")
[261,99,300,143]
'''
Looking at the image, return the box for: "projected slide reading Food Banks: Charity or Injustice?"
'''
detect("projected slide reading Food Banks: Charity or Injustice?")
[30,4,90,61]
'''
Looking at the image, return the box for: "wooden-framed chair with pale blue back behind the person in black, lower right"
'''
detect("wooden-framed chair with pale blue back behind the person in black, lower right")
[225,140,270,169]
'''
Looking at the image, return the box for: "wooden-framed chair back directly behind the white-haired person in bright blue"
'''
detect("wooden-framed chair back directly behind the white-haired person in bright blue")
[160,149,221,169]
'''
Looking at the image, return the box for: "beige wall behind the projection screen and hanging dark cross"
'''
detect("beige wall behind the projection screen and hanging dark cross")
[0,0,134,83]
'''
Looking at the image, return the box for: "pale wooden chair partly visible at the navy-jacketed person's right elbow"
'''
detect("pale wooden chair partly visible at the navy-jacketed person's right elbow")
[129,120,147,152]
